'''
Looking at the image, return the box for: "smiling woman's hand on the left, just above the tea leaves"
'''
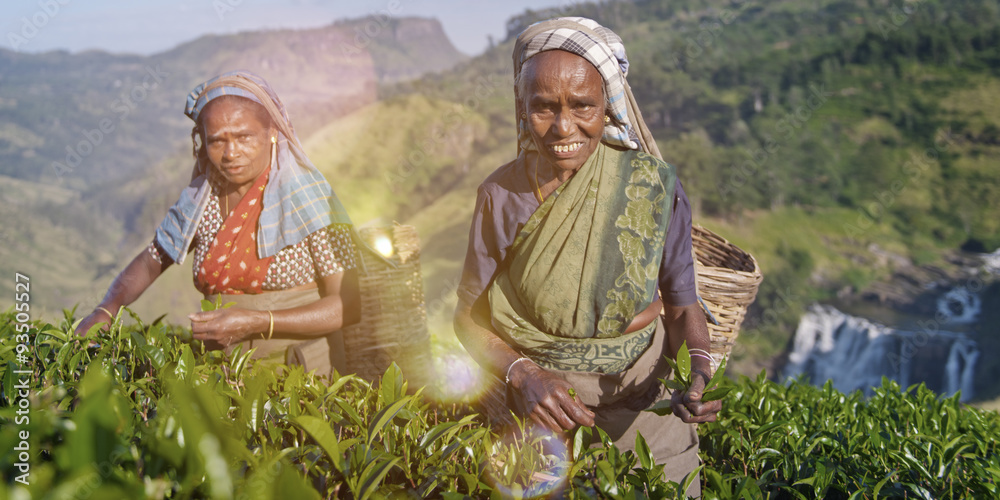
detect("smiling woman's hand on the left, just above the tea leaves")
[510,361,594,432]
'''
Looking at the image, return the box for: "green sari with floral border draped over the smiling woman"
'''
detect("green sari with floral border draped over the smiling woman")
[489,143,676,373]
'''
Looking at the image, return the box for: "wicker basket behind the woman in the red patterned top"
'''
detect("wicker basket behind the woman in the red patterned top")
[344,224,433,389]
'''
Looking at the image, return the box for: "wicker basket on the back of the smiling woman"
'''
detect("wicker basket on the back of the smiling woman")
[691,225,763,363]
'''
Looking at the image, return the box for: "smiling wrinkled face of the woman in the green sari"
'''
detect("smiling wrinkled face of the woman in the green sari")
[522,50,605,172]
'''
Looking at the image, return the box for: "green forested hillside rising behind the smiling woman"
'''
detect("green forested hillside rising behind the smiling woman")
[382,0,1000,371]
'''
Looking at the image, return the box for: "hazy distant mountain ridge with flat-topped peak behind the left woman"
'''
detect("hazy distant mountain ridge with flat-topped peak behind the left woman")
[0,17,466,187]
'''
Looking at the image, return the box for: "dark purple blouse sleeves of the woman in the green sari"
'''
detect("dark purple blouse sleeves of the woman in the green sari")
[458,161,697,306]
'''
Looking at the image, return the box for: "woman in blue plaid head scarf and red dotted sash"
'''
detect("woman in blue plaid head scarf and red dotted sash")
[77,72,359,370]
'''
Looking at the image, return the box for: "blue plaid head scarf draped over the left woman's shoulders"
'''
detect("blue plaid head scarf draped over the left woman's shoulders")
[150,71,351,264]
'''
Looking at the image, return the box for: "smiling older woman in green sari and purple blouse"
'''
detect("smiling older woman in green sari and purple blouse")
[455,18,721,492]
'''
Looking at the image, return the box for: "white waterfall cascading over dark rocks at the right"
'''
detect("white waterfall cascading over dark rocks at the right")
[784,304,979,401]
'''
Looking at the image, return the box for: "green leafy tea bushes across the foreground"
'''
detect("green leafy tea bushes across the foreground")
[0,311,1000,500]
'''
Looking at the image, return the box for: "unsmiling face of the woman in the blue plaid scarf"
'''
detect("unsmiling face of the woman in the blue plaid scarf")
[201,99,274,187]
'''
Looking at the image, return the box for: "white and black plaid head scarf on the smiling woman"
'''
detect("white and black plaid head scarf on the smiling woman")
[513,17,660,157]
